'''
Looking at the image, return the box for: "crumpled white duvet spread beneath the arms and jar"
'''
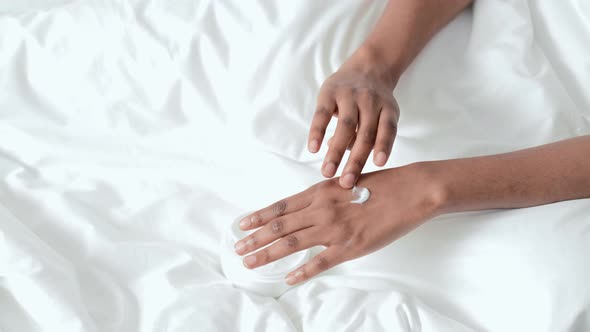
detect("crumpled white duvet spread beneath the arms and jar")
[0,0,590,332]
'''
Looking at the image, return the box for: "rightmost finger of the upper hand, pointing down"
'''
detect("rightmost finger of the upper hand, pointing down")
[373,106,397,166]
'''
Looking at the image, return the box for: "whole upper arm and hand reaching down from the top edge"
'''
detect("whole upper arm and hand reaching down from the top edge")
[308,0,471,188]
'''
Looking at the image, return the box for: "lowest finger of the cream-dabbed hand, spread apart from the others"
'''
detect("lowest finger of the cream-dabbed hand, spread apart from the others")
[286,246,345,285]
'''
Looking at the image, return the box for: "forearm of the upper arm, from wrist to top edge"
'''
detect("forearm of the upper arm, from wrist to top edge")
[349,0,472,82]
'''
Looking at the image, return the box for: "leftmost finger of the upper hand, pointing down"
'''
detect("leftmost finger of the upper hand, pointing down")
[307,91,336,153]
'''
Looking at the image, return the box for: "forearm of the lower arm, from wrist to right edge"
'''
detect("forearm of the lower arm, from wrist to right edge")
[422,135,590,213]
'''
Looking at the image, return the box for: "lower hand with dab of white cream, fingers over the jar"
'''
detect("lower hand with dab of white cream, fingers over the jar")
[235,163,444,285]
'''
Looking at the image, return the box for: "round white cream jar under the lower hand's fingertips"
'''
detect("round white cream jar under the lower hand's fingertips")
[221,215,310,297]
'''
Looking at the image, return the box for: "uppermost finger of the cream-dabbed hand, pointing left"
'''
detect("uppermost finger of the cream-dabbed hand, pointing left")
[240,190,311,230]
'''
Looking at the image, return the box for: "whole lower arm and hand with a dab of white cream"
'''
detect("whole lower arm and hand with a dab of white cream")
[236,135,590,284]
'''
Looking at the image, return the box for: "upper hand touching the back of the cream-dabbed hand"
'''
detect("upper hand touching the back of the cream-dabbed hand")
[308,51,399,189]
